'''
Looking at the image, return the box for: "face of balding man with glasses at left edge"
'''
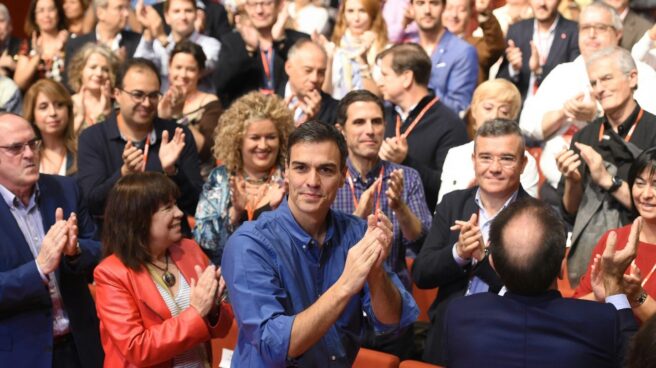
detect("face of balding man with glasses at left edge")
[0,114,39,194]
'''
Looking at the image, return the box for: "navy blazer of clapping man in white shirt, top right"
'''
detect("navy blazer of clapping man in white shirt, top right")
[498,14,580,100]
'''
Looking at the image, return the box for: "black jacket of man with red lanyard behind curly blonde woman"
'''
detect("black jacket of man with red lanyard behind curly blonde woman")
[214,29,310,107]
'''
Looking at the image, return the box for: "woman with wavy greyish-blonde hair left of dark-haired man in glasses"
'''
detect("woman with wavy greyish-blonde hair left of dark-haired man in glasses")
[68,43,118,134]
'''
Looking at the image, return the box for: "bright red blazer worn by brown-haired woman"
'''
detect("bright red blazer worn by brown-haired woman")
[94,239,233,368]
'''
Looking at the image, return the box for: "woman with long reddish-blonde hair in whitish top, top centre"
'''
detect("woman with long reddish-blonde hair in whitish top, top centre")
[328,0,388,99]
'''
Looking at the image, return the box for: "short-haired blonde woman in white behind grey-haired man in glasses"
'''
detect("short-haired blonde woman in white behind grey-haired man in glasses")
[437,79,539,203]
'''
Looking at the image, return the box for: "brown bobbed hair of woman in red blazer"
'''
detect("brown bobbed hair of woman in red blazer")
[102,172,180,271]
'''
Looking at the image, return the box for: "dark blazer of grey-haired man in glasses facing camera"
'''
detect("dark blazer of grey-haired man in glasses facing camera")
[412,186,529,365]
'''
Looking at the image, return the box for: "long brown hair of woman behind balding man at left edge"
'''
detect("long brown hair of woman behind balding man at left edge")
[23,79,77,175]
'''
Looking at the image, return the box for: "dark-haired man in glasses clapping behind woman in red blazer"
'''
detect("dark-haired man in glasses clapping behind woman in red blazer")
[77,58,203,236]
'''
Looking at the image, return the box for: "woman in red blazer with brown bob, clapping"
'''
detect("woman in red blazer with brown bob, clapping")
[94,172,232,368]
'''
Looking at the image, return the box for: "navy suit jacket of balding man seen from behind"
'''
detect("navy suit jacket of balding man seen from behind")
[444,290,638,368]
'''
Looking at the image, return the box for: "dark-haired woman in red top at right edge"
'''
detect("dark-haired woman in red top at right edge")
[574,148,656,322]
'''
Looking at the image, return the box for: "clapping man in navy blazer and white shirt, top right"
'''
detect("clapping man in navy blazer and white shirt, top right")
[498,0,579,101]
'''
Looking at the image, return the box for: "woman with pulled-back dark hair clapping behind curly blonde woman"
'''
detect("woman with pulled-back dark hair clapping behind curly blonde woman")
[159,41,223,178]
